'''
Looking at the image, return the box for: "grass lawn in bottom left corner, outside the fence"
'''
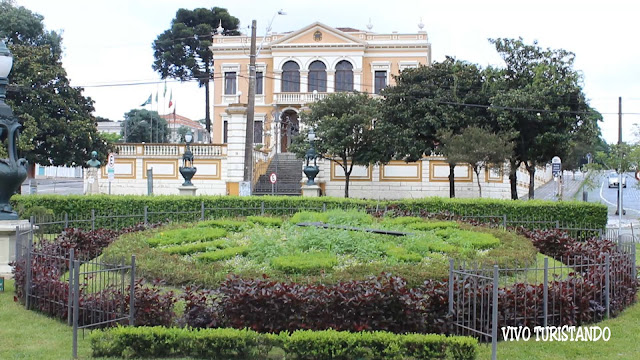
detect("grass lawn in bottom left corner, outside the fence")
[0,280,91,360]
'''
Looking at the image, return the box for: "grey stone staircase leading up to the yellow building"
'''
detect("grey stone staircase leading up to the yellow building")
[253,153,304,195]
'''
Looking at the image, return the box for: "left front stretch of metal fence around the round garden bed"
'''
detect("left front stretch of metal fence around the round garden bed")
[15,219,135,358]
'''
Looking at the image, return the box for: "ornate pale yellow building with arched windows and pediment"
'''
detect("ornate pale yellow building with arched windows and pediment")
[211,22,431,148]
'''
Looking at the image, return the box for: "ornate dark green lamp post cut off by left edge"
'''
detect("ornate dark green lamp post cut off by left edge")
[0,40,27,220]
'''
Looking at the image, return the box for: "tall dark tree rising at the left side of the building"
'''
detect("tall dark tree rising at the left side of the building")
[153,7,240,140]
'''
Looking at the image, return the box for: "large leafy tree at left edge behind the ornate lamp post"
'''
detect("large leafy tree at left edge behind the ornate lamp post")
[0,1,112,166]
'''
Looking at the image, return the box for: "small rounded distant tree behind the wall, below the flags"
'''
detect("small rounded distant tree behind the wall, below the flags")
[120,109,169,143]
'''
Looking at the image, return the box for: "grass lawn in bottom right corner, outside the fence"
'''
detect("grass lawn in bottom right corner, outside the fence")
[478,296,640,360]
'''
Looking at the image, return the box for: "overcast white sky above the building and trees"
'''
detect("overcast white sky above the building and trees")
[17,0,640,143]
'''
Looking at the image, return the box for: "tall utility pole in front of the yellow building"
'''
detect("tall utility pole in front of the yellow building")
[243,20,256,195]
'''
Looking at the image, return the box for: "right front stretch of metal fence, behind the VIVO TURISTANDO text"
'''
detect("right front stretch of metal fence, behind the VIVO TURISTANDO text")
[448,237,638,359]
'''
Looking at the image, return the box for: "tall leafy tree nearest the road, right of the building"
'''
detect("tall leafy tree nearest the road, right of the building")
[490,38,601,199]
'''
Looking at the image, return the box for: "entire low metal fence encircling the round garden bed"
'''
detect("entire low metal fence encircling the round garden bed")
[11,205,637,358]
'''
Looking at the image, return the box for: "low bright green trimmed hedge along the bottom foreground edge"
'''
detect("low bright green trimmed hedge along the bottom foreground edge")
[91,327,478,360]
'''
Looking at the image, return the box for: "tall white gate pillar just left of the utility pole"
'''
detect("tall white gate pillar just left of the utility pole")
[226,105,247,182]
